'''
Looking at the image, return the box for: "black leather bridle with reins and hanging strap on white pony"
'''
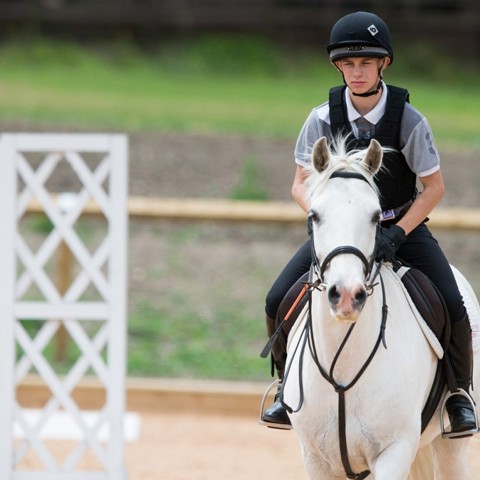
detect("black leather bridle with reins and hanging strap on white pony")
[280,171,388,480]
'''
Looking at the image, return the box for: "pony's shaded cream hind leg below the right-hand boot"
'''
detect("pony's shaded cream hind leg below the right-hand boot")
[432,435,470,480]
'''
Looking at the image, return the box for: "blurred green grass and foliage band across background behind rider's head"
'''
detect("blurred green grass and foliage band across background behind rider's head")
[0,36,480,147]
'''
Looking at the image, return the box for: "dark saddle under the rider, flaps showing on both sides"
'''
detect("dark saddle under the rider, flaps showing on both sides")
[276,261,456,432]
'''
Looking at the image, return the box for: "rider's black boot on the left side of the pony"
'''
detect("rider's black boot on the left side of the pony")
[262,315,292,428]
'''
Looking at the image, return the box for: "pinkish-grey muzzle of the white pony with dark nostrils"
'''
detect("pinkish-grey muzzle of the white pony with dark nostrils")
[327,284,368,322]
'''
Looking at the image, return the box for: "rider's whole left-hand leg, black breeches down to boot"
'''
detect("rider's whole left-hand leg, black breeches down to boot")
[263,241,312,425]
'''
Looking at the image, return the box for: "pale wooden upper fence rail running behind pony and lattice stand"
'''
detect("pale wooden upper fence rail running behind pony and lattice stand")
[28,196,480,230]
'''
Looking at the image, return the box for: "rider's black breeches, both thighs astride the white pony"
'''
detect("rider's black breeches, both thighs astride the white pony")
[265,223,465,323]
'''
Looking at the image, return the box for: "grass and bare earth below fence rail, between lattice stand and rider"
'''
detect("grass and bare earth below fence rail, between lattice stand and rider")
[128,224,280,380]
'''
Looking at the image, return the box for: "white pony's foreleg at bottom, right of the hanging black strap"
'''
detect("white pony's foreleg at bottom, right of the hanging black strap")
[371,438,423,480]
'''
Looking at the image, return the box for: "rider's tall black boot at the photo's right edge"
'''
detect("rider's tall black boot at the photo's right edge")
[446,315,478,436]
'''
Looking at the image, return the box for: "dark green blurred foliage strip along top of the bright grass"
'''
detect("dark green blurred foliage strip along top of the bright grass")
[0,33,478,80]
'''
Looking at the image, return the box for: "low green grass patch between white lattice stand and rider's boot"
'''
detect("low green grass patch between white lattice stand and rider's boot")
[128,299,268,380]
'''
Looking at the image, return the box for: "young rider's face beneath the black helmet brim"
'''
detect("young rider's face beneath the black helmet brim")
[336,57,390,94]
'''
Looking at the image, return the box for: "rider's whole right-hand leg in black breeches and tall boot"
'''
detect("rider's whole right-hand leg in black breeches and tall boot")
[398,224,477,433]
